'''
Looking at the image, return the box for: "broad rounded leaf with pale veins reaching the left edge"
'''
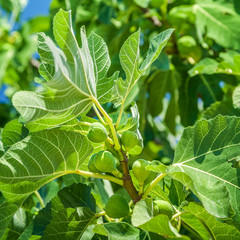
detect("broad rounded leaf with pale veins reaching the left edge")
[0,129,92,236]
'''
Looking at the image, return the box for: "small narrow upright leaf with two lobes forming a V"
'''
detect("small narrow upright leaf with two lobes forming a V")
[115,29,173,106]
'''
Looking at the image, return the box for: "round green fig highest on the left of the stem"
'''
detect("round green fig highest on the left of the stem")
[87,122,108,143]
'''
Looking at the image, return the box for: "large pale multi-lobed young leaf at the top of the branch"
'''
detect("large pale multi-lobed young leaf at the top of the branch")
[13,9,118,131]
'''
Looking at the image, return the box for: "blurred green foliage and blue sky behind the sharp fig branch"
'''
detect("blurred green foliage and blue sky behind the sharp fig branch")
[0,0,240,239]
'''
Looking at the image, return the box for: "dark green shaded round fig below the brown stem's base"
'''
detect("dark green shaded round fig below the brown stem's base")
[105,194,129,218]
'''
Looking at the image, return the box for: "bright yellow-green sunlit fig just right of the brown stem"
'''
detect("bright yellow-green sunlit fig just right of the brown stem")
[132,159,150,185]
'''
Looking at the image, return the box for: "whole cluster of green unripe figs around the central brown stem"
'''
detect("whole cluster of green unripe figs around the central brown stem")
[87,122,173,219]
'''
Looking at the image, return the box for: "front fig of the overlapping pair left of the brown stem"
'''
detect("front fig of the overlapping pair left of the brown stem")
[95,151,122,178]
